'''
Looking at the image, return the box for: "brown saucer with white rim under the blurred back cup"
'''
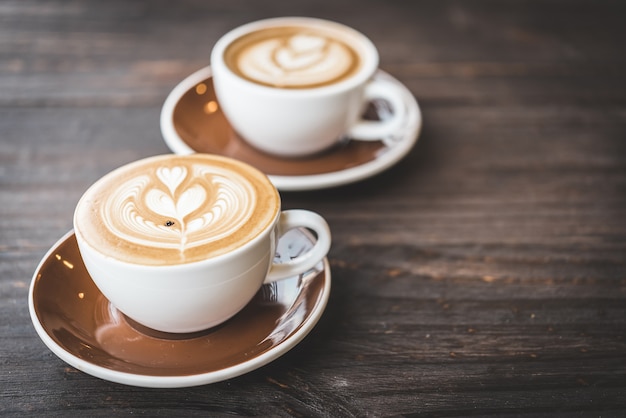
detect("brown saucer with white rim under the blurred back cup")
[161,67,422,190]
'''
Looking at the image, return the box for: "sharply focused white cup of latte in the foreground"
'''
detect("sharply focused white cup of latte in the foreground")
[74,154,331,333]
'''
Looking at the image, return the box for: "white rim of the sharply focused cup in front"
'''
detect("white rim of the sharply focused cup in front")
[72,154,282,271]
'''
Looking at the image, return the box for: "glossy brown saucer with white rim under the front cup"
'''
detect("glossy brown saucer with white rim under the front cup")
[29,230,330,387]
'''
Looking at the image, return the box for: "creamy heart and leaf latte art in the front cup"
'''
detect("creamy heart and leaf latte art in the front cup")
[102,167,251,257]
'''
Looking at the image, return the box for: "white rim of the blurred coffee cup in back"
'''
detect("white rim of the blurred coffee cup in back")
[211,16,380,96]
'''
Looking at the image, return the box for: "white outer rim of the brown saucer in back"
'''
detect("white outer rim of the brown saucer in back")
[160,65,423,191]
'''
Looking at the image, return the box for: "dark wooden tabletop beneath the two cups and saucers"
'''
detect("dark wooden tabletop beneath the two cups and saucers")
[0,0,626,417]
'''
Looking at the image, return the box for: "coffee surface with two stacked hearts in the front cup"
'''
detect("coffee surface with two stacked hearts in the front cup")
[75,154,280,265]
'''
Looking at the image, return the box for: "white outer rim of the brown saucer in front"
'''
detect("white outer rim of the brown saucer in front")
[28,229,331,388]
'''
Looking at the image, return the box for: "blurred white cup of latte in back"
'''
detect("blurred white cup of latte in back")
[211,17,405,157]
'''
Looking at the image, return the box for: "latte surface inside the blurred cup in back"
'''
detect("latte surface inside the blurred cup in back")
[224,25,362,89]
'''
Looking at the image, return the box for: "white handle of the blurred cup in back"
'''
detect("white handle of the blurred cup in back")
[347,79,407,141]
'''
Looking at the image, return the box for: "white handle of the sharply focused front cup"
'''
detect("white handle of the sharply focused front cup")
[264,209,331,283]
